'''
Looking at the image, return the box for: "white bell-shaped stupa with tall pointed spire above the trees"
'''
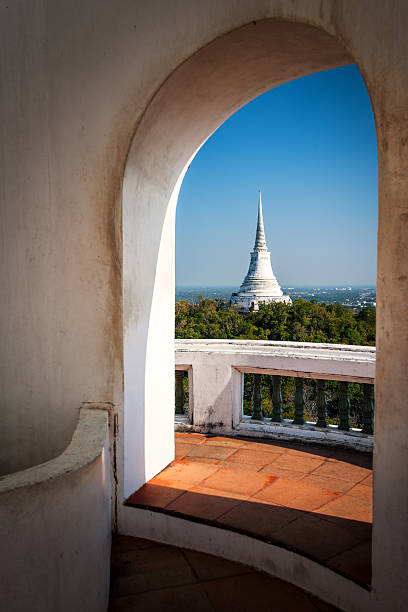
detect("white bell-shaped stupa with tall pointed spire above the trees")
[231,192,292,310]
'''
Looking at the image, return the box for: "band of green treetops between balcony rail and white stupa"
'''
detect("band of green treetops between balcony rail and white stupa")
[176,298,375,346]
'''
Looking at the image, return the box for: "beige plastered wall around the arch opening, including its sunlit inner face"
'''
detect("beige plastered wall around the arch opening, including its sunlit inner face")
[0,0,408,610]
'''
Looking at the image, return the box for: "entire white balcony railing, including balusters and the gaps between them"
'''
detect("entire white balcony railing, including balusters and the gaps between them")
[175,340,375,450]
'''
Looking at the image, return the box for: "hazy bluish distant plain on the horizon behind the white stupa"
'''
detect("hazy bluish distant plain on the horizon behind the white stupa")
[176,285,376,308]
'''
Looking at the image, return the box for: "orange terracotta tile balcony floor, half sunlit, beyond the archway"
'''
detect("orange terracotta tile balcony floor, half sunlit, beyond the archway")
[127,433,372,584]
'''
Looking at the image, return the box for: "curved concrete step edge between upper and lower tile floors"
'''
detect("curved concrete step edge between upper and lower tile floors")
[119,506,372,612]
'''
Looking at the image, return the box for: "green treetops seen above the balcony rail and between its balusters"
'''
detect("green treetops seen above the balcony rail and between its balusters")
[176,297,375,427]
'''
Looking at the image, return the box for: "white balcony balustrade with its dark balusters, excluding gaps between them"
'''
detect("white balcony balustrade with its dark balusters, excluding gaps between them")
[175,339,376,449]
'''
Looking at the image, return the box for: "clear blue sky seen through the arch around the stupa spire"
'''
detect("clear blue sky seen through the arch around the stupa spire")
[176,66,377,286]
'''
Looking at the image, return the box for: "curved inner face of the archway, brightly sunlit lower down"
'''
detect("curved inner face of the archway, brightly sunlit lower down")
[123,20,353,496]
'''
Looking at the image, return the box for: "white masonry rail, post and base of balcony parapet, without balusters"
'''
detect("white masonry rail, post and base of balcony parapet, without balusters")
[175,340,376,450]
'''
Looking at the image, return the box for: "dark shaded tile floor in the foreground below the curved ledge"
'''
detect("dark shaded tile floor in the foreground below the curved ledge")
[109,536,342,612]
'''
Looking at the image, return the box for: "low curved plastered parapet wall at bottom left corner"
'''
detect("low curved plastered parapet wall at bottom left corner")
[0,409,111,612]
